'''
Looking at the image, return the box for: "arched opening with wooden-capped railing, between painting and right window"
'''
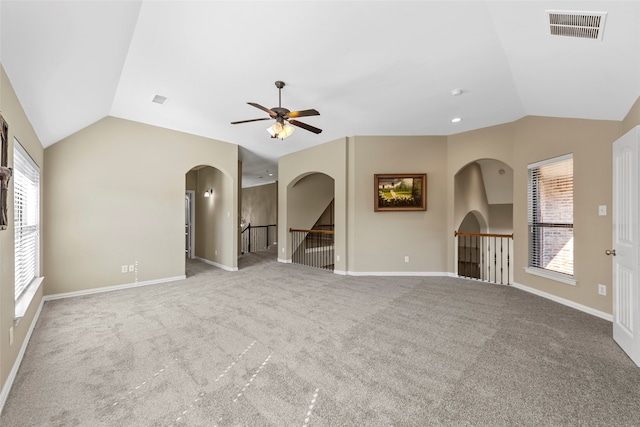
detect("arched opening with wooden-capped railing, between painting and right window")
[454,159,513,283]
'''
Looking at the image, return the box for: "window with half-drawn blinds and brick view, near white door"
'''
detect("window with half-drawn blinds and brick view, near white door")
[527,154,575,284]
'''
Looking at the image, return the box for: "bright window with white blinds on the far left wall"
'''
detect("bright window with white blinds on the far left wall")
[13,139,40,301]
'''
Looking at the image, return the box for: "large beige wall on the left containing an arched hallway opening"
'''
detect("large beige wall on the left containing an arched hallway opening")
[44,117,238,294]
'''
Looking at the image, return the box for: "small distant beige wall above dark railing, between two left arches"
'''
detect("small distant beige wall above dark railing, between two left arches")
[241,182,278,229]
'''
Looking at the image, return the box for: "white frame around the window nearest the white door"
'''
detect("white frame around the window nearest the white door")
[525,153,576,285]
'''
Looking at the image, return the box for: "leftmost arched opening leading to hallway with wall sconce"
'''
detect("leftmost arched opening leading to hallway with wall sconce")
[185,165,237,271]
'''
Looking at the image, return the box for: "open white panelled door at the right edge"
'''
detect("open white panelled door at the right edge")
[607,127,640,366]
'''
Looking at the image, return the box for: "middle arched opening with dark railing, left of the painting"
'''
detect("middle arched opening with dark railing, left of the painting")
[287,172,335,270]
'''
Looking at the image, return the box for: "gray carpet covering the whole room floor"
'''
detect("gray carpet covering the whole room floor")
[0,252,640,427]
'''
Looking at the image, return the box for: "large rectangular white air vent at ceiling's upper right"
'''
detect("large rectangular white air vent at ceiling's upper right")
[547,10,607,40]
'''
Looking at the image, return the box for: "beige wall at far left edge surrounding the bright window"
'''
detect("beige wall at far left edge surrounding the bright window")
[0,66,46,396]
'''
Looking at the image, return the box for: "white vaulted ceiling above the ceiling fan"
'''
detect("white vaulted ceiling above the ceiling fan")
[0,0,640,186]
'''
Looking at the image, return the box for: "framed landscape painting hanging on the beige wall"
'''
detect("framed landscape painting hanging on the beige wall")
[373,173,427,212]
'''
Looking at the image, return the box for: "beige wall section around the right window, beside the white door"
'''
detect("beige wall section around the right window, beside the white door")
[512,117,620,313]
